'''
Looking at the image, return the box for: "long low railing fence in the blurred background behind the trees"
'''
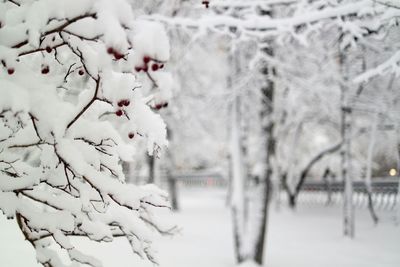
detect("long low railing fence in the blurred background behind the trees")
[133,172,399,213]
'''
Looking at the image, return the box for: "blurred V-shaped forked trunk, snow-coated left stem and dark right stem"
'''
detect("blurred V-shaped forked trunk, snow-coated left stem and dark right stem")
[231,42,276,265]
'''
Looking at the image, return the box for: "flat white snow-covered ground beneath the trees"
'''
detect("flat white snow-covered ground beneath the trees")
[0,189,400,267]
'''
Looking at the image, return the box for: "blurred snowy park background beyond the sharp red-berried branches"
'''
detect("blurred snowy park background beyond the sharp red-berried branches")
[126,0,400,266]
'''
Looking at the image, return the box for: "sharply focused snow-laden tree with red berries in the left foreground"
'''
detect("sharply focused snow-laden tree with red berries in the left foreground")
[0,0,175,266]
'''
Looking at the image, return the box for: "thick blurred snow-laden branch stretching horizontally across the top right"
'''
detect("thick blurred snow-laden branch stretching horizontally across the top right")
[149,0,396,35]
